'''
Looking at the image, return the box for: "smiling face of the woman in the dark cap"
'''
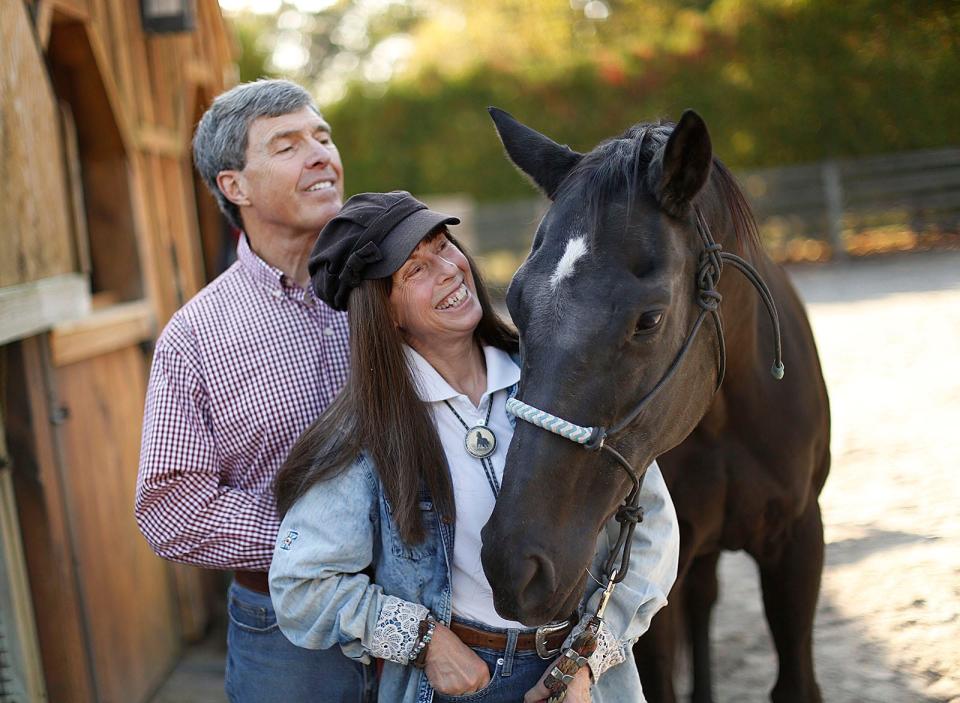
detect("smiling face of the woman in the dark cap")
[390,231,483,351]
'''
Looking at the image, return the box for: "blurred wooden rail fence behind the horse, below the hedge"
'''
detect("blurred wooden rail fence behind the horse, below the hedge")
[456,148,960,268]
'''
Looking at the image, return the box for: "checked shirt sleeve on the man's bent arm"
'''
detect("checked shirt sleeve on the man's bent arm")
[134,321,279,571]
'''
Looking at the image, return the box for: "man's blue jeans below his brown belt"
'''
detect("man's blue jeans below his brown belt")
[224,583,373,703]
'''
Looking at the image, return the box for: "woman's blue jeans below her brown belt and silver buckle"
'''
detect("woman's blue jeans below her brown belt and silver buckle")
[433,618,558,703]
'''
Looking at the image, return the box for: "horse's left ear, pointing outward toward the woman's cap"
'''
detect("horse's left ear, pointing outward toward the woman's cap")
[487,107,583,200]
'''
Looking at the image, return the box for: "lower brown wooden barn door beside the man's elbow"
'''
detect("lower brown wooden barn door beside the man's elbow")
[7,330,179,703]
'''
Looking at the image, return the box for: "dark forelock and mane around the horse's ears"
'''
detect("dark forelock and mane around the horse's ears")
[556,121,760,251]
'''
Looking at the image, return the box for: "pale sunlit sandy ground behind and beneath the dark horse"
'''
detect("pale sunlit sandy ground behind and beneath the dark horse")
[155,251,960,703]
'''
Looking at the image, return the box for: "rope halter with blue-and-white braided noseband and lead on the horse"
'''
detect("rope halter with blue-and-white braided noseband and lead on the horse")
[506,208,783,703]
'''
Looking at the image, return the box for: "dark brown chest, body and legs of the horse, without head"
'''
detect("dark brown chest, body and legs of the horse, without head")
[634,245,830,703]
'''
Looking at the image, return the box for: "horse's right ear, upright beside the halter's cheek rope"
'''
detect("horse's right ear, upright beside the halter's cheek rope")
[649,110,713,215]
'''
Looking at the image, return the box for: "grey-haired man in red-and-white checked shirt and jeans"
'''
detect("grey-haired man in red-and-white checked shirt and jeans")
[136,80,367,703]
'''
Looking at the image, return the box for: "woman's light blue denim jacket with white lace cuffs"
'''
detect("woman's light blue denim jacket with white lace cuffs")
[270,388,680,703]
